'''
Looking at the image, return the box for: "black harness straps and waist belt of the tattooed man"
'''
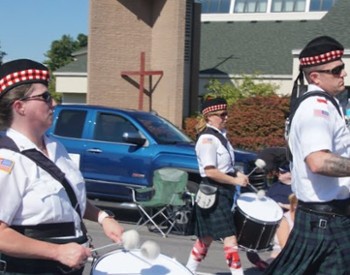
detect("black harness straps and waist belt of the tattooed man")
[285,90,350,223]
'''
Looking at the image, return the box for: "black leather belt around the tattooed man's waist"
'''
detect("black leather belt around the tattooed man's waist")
[298,198,350,216]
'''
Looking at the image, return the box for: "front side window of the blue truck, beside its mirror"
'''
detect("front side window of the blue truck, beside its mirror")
[94,113,137,142]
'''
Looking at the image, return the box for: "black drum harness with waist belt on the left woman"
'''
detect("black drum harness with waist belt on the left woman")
[0,136,91,273]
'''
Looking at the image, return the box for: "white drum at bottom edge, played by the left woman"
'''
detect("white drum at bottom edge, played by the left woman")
[91,249,192,275]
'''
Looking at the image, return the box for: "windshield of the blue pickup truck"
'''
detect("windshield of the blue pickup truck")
[134,113,193,144]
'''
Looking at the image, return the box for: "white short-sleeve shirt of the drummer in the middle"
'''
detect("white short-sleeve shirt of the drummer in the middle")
[196,125,235,177]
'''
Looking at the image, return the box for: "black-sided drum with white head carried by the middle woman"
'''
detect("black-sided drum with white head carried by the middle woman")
[234,193,283,251]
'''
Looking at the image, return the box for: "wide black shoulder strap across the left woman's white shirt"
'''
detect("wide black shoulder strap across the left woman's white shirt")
[0,136,84,230]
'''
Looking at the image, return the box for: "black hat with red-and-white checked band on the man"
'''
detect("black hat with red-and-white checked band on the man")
[299,36,344,68]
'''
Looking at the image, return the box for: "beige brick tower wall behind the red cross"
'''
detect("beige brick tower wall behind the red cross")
[87,0,187,126]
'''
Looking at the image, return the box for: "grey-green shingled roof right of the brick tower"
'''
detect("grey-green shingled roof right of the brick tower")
[200,0,350,75]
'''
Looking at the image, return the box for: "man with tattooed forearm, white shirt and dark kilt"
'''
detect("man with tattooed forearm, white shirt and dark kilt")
[265,36,350,275]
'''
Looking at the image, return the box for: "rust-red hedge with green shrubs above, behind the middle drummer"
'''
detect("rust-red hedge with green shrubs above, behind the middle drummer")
[185,76,290,151]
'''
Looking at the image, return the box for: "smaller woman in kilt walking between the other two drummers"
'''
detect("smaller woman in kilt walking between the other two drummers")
[186,98,248,274]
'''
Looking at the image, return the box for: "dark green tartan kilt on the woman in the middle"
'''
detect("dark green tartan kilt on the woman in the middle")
[194,186,236,240]
